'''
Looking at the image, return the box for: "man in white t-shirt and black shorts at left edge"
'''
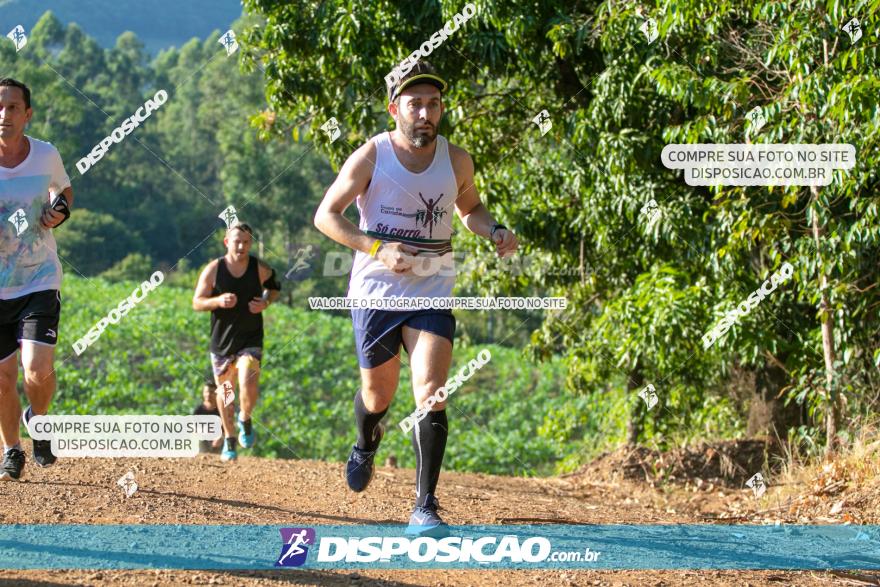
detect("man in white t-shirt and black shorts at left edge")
[0,78,73,481]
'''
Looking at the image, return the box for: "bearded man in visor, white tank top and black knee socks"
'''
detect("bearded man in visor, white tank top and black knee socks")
[315,61,517,535]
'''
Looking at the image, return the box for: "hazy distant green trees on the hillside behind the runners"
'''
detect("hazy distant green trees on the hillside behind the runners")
[0,12,330,285]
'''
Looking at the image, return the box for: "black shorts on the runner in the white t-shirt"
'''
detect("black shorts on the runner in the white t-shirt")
[0,289,61,361]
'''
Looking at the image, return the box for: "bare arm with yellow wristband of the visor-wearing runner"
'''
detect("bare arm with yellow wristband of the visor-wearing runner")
[314,141,376,253]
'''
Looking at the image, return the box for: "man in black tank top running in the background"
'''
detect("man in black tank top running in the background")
[193,224,281,461]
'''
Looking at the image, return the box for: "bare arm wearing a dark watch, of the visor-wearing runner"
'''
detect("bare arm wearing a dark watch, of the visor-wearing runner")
[449,145,517,257]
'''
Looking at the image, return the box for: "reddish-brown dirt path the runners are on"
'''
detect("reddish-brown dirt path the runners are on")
[0,455,866,587]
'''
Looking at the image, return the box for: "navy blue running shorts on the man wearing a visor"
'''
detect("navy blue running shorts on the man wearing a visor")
[351,309,455,369]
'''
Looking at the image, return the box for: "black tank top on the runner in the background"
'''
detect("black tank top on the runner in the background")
[211,255,263,355]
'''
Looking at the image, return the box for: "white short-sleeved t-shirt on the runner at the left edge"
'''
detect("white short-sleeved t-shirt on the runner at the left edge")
[0,137,70,300]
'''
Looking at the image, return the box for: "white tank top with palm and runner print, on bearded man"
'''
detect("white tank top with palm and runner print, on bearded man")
[348,132,458,298]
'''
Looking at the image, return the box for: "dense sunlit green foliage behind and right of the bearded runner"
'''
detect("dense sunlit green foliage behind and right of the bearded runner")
[245,0,880,454]
